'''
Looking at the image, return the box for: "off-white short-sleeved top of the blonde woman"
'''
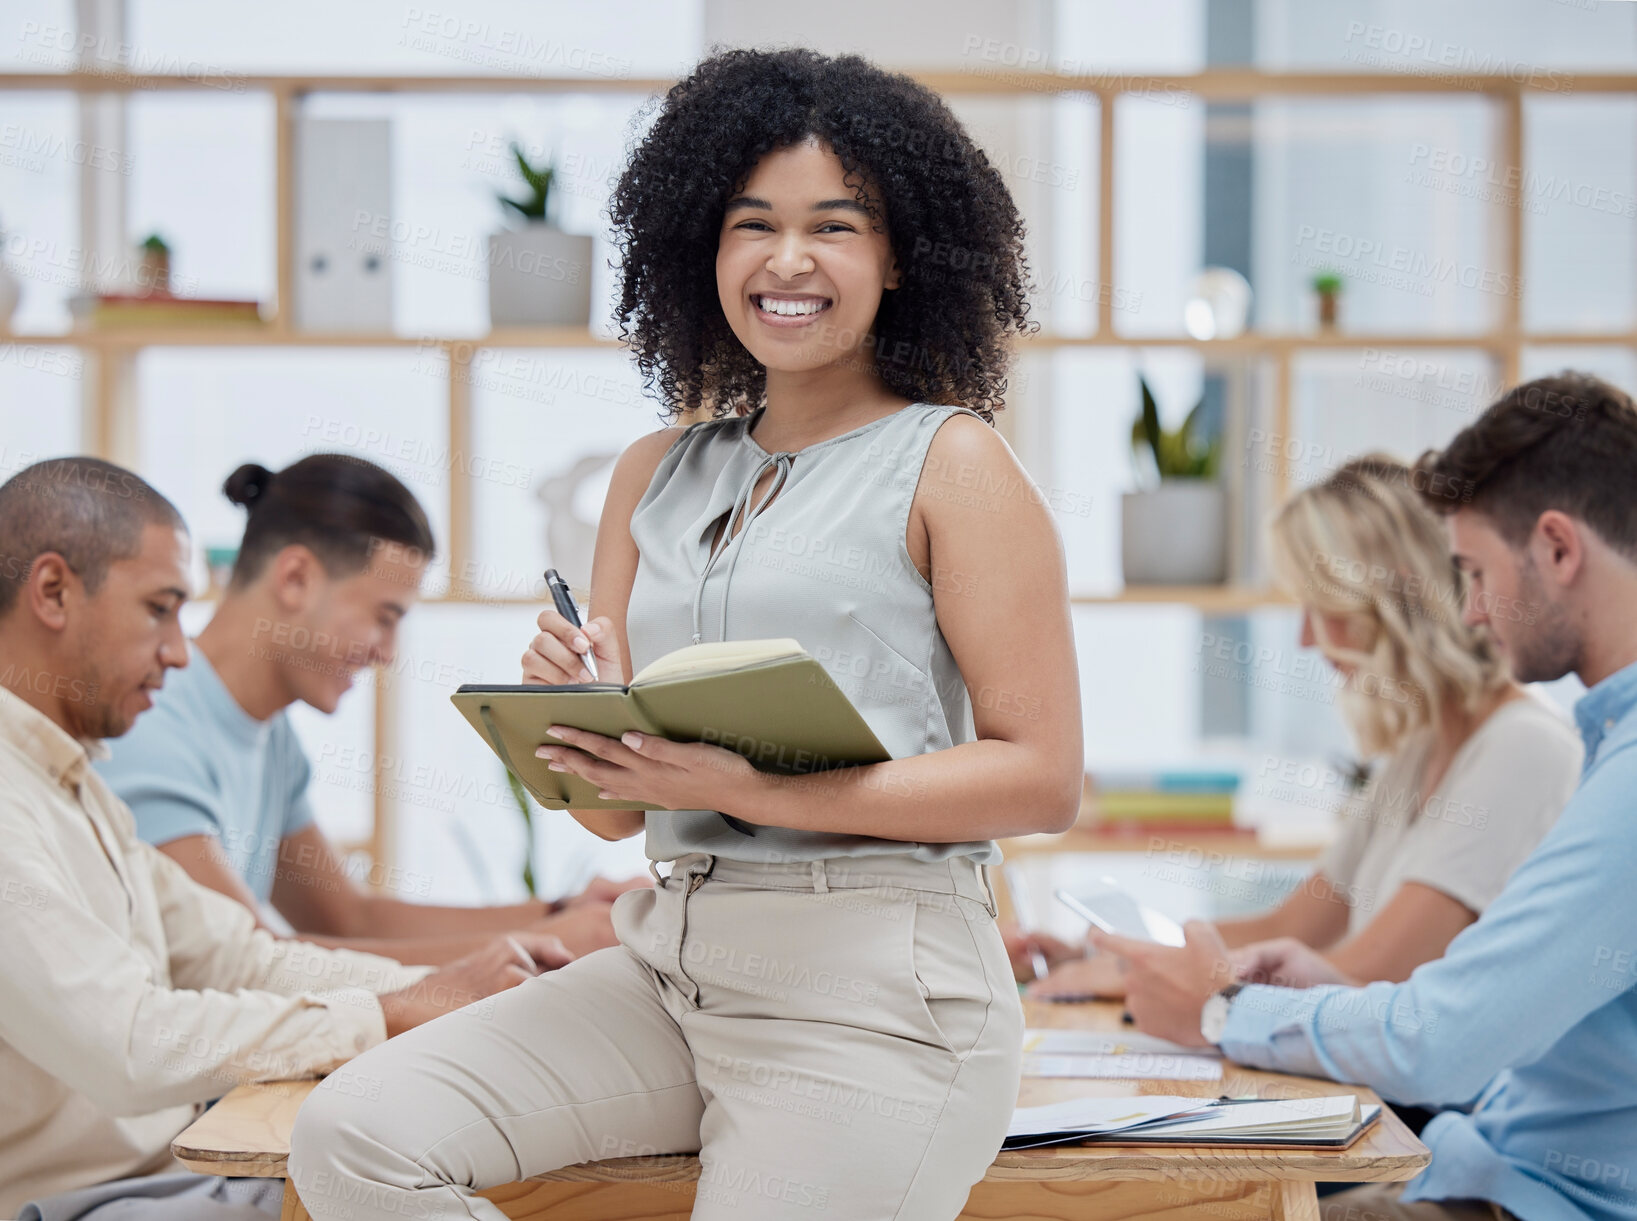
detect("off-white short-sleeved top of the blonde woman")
[1318,692,1585,936]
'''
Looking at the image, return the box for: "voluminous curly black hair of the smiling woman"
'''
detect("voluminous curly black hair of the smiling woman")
[609,47,1039,424]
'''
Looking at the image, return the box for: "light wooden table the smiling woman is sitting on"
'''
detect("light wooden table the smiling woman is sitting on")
[172,1000,1431,1221]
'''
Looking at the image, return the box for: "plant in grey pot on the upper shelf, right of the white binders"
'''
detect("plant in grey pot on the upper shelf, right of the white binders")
[488,141,591,327]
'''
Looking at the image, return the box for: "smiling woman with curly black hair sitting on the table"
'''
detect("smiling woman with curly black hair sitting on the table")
[290,40,1085,1221]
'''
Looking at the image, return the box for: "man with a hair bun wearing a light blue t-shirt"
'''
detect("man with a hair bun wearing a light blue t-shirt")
[98,453,648,964]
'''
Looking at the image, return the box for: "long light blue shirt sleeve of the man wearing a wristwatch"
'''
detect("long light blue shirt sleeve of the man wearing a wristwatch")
[1221,743,1637,1105]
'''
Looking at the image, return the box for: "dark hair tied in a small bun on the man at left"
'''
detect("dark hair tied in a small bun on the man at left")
[223,453,435,589]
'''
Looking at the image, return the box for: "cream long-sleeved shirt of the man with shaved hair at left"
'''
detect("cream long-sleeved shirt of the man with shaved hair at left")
[0,687,431,1216]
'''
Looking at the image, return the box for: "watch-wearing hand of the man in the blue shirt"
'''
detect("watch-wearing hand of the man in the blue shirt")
[1085,920,1238,1048]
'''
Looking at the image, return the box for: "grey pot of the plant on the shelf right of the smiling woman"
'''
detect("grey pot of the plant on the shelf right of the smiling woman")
[1120,480,1228,584]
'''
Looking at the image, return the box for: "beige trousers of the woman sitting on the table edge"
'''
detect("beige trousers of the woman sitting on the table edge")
[290,853,1023,1221]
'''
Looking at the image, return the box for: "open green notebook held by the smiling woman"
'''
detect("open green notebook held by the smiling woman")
[450,637,892,810]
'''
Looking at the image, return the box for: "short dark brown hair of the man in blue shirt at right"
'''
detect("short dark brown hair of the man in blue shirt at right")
[1416,370,1637,560]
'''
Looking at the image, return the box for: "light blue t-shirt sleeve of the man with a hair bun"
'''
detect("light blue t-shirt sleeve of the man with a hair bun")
[95,704,224,846]
